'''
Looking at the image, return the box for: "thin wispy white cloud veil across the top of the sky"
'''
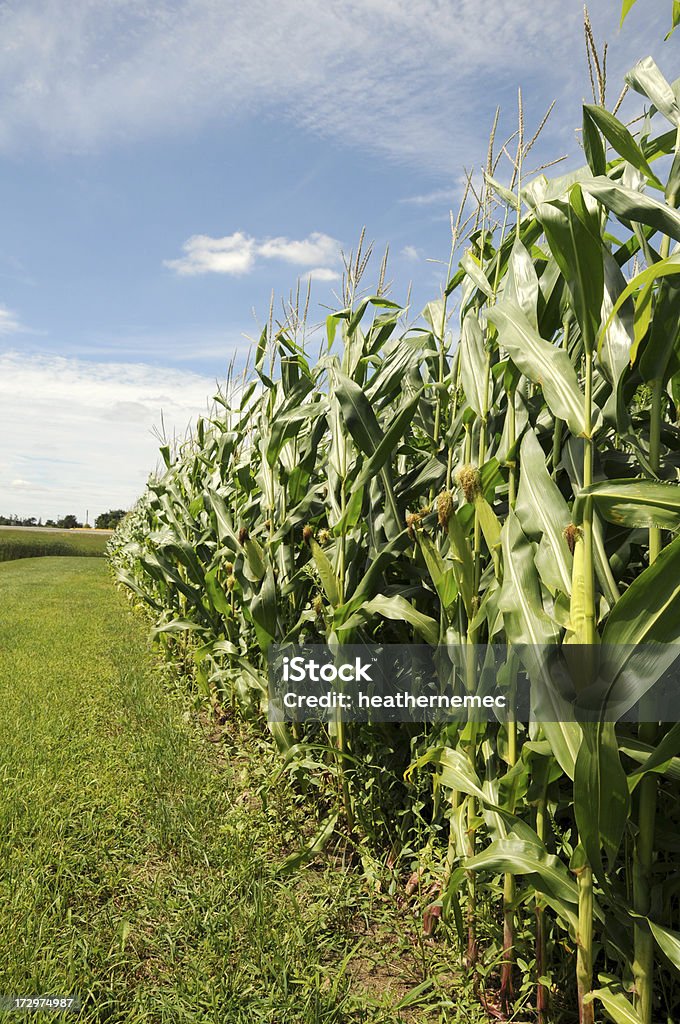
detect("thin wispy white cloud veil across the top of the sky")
[0,0,672,173]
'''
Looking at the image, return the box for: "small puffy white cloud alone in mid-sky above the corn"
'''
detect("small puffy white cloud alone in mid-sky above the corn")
[164,231,340,281]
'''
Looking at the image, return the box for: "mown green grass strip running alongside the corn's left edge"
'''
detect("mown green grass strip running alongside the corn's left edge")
[0,558,477,1024]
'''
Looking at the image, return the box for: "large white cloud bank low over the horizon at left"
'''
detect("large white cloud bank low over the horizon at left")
[0,352,217,521]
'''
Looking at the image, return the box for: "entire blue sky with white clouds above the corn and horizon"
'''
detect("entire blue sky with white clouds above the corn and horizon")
[0,0,680,518]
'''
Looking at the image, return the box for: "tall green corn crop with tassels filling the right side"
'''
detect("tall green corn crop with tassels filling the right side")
[111,39,680,1024]
